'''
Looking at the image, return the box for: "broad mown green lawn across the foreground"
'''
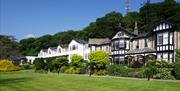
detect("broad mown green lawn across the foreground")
[0,71,180,91]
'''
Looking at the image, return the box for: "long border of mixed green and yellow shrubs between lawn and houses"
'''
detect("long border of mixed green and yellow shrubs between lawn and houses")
[0,51,180,80]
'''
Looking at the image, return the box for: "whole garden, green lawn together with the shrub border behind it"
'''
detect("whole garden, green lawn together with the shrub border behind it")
[0,51,180,91]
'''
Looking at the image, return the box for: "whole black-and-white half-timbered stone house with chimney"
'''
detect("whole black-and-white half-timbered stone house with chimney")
[111,21,180,64]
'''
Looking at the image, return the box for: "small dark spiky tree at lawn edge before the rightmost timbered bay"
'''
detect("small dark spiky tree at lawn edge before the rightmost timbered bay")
[144,61,158,81]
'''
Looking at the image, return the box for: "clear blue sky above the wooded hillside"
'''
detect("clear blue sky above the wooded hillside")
[0,0,177,40]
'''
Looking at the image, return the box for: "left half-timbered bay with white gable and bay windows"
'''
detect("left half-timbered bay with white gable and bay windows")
[110,28,136,64]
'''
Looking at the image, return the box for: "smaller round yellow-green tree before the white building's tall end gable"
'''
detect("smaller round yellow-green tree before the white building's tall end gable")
[71,54,83,67]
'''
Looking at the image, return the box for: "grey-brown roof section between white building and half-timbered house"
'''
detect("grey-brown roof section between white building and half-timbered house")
[88,38,111,45]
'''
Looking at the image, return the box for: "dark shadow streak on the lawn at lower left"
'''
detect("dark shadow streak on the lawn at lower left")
[0,77,32,85]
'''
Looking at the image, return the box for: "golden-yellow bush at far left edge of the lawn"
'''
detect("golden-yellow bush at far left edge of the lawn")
[0,60,20,72]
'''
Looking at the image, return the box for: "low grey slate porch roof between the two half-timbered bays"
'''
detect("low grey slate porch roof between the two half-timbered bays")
[127,47,156,54]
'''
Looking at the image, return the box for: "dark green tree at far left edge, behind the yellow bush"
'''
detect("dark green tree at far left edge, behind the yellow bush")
[0,35,20,61]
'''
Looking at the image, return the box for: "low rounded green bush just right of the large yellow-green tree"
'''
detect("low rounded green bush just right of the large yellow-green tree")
[107,64,128,76]
